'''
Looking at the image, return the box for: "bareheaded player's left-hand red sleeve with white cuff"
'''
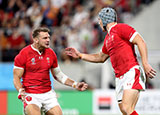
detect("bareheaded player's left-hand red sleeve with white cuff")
[14,52,26,69]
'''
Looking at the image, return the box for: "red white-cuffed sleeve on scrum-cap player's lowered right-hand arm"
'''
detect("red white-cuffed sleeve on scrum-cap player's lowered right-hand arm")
[118,24,138,42]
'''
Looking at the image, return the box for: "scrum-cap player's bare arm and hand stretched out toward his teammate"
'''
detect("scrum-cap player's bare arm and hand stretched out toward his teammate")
[65,47,109,63]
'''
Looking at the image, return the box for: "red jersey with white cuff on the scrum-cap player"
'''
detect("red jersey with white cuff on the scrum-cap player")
[102,24,138,77]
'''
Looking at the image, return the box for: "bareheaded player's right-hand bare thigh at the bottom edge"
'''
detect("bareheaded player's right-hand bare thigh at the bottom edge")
[46,105,62,115]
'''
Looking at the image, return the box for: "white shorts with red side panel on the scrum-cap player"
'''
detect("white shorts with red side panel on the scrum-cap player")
[115,65,146,102]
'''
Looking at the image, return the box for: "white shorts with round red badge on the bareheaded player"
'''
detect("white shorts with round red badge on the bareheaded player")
[24,90,60,112]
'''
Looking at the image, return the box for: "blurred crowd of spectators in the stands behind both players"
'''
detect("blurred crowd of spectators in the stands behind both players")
[0,0,153,62]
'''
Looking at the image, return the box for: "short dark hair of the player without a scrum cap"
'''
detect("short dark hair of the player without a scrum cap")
[32,27,50,38]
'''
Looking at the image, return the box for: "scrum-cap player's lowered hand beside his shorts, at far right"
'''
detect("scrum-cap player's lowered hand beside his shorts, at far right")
[143,64,156,79]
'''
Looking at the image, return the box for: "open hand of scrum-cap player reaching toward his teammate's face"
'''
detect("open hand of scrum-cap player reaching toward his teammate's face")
[65,47,80,59]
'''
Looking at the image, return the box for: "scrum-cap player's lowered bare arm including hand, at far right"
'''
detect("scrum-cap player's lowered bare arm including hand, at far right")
[132,34,156,79]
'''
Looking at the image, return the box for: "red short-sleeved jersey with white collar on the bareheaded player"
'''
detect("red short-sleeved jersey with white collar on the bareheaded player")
[14,45,58,93]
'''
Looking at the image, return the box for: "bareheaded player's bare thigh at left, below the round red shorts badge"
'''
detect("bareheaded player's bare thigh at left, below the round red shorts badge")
[24,104,41,115]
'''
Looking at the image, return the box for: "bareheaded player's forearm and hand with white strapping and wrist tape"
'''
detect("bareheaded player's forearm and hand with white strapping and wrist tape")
[51,67,88,91]
